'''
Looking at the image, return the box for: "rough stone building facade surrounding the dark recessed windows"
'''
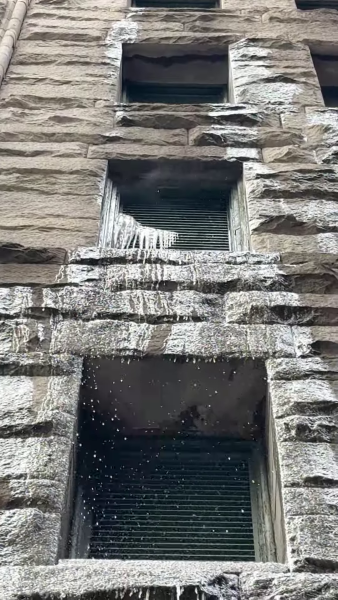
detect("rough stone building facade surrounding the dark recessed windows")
[0,0,338,600]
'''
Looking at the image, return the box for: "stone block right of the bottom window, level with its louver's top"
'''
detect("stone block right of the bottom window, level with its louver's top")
[279,442,338,487]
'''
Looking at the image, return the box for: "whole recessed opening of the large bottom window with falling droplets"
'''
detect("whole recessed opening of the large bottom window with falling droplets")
[71,358,275,561]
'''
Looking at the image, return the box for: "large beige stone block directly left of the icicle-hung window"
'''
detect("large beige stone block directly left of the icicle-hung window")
[0,156,106,248]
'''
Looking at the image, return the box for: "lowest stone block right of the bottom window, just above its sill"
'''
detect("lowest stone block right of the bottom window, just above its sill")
[285,515,338,571]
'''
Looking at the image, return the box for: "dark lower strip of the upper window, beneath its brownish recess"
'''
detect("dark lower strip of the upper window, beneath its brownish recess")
[125,81,227,104]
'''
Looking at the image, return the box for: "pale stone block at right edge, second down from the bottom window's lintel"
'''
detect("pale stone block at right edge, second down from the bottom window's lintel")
[268,380,338,419]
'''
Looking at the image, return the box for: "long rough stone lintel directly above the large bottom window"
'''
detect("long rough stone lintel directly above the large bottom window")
[51,320,294,358]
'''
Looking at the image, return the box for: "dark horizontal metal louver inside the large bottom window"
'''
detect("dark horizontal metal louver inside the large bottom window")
[86,437,255,561]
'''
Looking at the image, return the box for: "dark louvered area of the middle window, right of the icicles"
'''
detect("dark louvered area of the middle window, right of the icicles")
[121,188,230,250]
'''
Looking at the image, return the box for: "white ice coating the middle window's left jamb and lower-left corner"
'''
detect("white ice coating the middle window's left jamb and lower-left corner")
[99,180,178,250]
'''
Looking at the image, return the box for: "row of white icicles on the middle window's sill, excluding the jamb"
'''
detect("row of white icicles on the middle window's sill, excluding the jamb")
[113,213,178,250]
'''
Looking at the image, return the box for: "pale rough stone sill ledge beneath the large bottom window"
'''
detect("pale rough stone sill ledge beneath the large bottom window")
[0,560,286,600]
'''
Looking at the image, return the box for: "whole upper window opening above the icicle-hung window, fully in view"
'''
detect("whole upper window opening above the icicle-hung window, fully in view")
[122,44,228,104]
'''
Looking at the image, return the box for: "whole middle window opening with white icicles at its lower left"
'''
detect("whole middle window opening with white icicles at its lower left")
[98,159,250,251]
